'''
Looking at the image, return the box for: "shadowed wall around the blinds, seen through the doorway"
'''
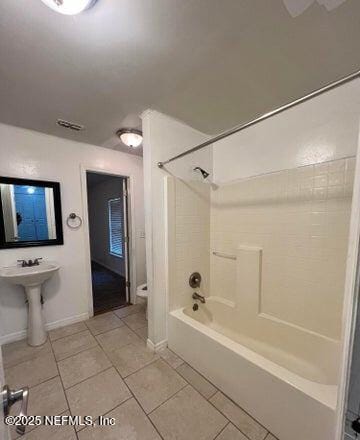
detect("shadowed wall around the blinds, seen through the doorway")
[88,177,125,276]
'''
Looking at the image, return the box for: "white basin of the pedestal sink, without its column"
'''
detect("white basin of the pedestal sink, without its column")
[0,262,60,287]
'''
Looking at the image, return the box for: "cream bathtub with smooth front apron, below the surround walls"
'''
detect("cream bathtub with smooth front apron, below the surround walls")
[169,297,339,440]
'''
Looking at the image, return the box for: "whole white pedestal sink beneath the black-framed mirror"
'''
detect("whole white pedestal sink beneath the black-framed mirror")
[0,262,60,346]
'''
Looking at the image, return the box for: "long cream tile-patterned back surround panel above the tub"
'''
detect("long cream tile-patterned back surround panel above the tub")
[210,158,355,340]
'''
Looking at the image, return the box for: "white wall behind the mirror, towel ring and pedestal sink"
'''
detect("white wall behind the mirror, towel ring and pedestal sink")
[0,125,146,342]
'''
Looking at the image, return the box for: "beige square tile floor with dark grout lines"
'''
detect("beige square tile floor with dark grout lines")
[2,305,276,440]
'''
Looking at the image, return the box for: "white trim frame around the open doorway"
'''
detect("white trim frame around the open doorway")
[80,165,136,317]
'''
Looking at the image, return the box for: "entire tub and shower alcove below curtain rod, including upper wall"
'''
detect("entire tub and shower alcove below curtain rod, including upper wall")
[160,75,358,440]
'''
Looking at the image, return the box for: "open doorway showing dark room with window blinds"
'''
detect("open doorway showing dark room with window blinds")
[86,171,130,315]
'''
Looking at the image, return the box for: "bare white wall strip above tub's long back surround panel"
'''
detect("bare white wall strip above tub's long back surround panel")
[213,80,360,182]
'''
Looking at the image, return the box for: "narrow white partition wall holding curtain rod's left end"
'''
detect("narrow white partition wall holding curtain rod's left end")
[142,110,212,346]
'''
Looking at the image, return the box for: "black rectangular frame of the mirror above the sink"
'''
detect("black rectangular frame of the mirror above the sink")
[0,176,64,249]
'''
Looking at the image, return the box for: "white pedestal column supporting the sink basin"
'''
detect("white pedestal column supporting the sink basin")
[25,285,47,346]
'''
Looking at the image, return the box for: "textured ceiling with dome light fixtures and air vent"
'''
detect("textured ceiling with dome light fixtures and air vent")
[0,0,360,154]
